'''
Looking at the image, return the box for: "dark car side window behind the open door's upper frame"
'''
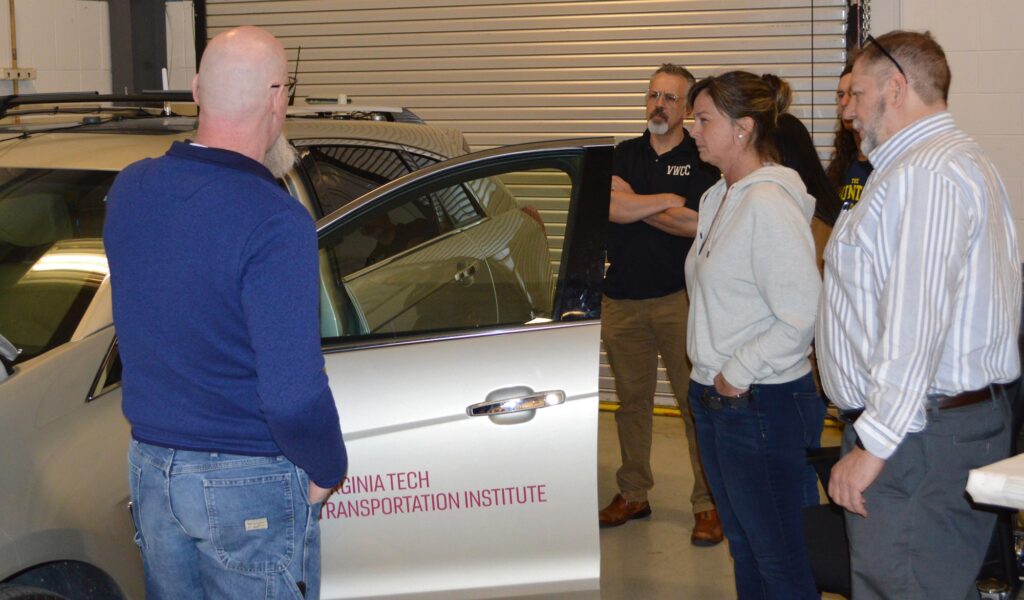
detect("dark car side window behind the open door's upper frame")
[301,144,437,216]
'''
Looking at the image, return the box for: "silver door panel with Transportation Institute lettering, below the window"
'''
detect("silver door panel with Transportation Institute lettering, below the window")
[321,322,600,598]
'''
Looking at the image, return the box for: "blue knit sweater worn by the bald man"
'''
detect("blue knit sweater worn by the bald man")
[103,142,347,487]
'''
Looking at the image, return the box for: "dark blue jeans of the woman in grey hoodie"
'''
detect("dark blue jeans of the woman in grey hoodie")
[689,375,823,600]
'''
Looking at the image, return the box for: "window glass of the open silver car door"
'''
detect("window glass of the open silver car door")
[321,152,579,342]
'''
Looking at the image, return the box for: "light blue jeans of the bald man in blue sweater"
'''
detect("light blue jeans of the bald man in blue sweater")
[128,440,319,600]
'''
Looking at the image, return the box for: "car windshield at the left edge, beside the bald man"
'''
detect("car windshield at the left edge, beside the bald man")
[0,169,117,361]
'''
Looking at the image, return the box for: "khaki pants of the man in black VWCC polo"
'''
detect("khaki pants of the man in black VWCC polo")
[601,290,715,513]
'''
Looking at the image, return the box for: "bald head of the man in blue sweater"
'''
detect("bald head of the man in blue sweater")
[195,27,288,122]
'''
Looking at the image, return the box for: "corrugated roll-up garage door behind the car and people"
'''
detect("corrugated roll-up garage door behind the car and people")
[206,0,847,404]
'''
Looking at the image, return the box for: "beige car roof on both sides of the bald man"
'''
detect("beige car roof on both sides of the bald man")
[0,115,468,171]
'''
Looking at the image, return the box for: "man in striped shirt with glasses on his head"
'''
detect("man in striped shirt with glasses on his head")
[817,32,1021,600]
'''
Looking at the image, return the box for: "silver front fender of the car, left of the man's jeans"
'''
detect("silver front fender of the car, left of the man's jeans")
[0,327,142,598]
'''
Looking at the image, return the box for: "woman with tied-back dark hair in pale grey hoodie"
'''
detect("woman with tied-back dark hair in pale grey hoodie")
[686,71,822,600]
